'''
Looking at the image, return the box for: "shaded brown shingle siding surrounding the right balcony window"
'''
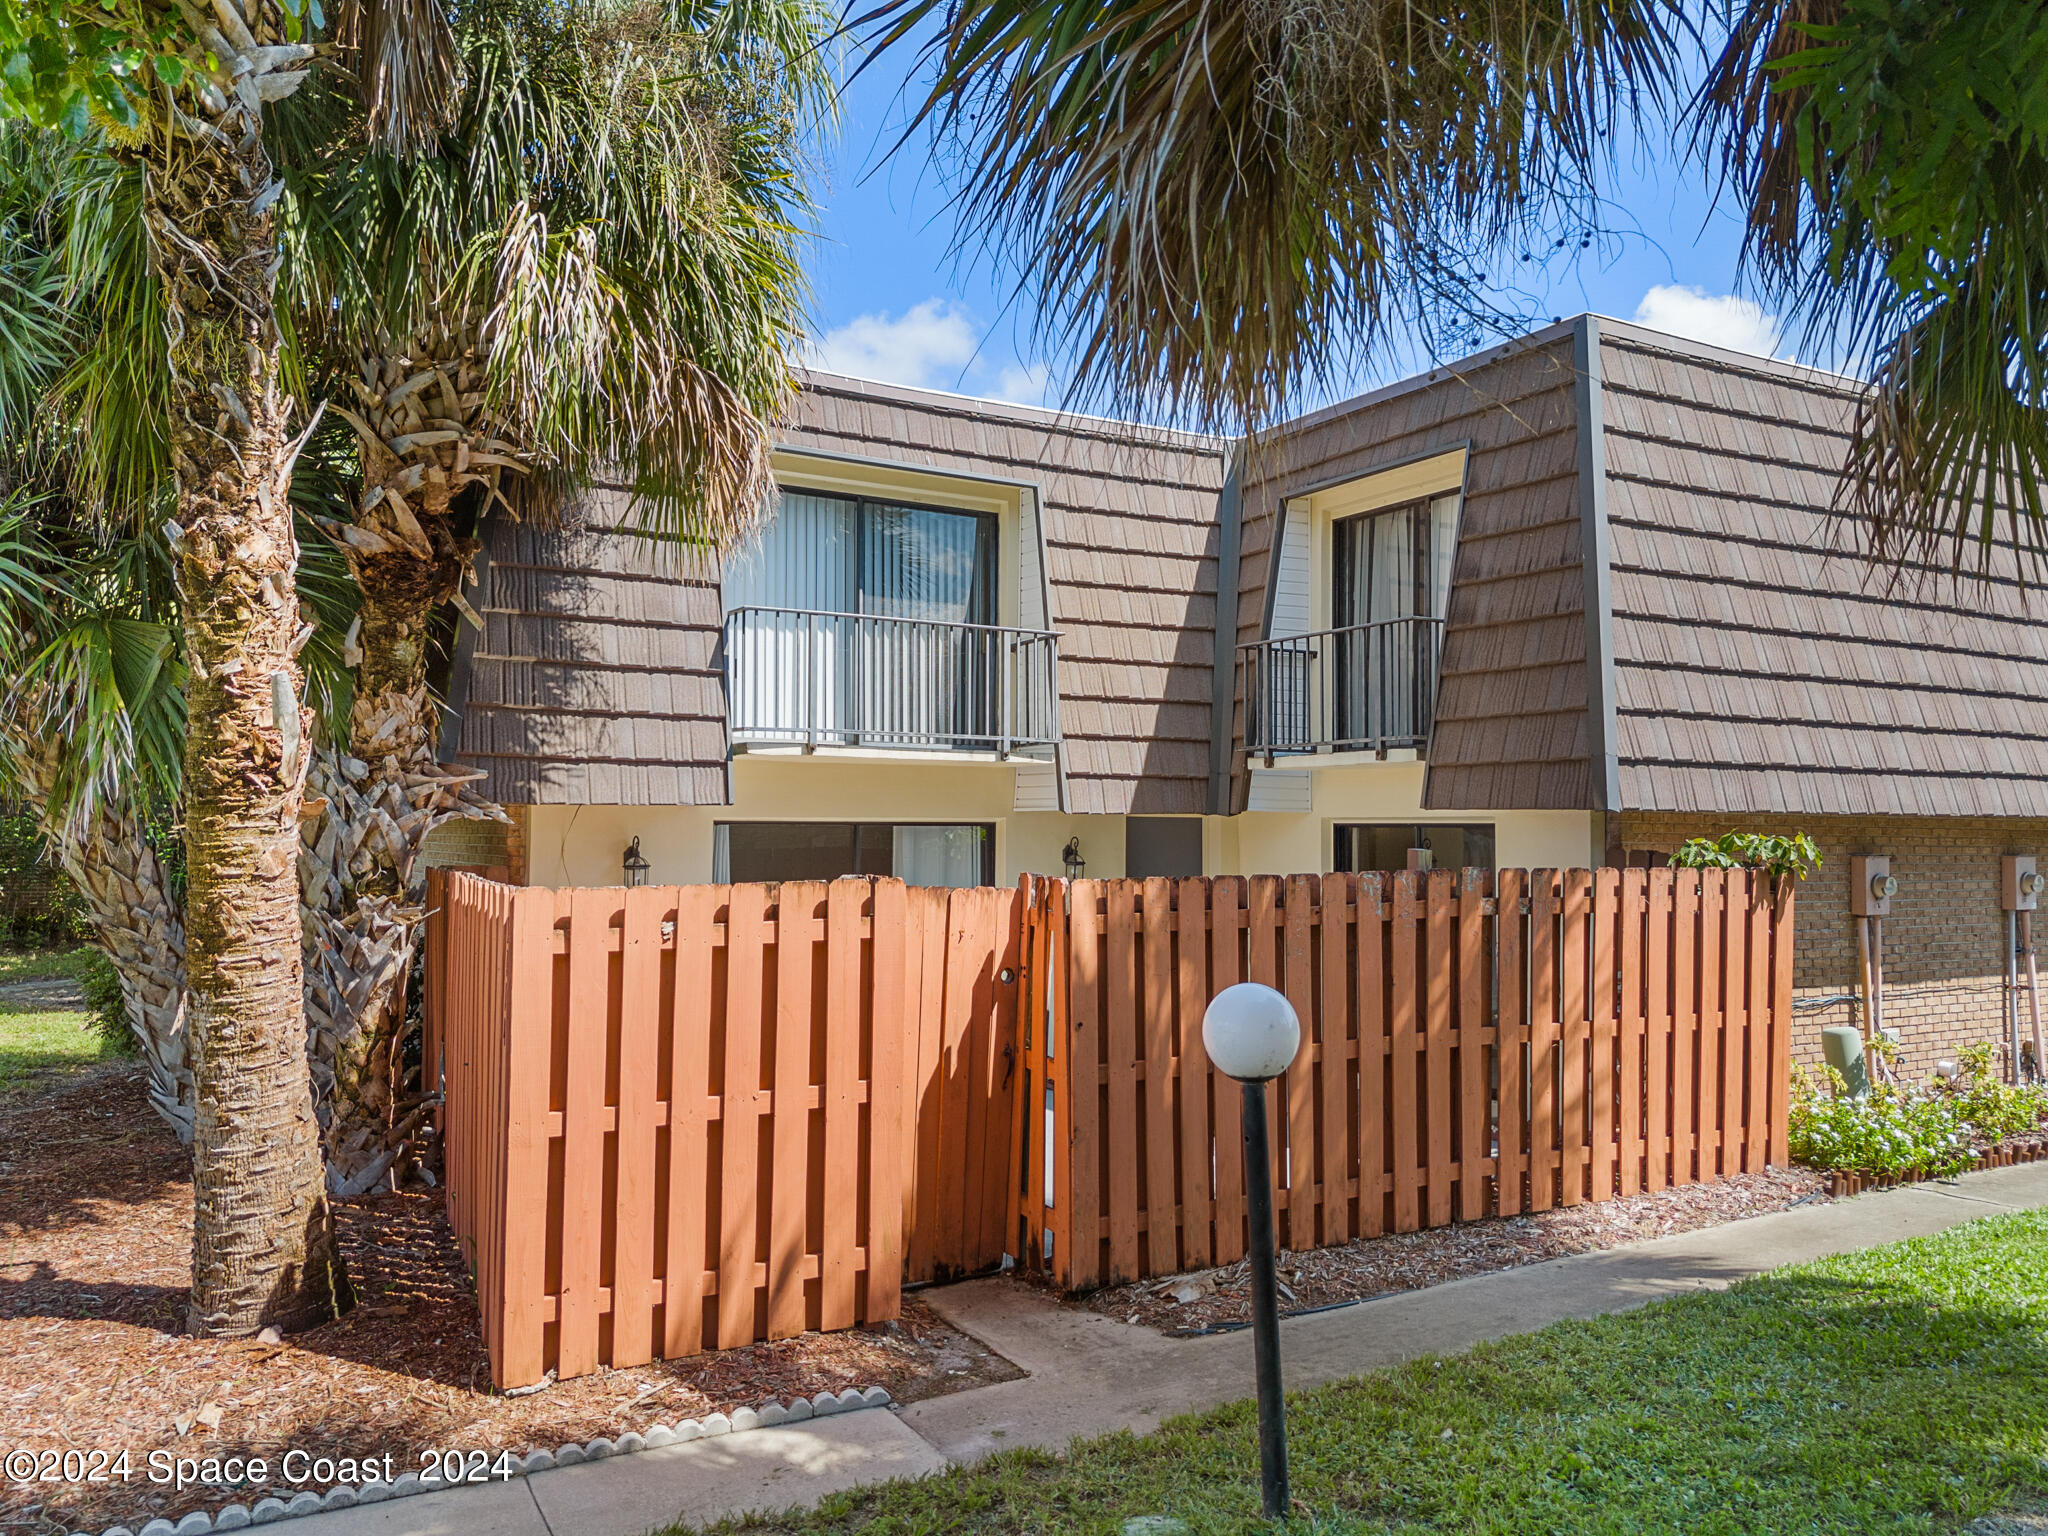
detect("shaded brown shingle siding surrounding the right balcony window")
[1233,326,1589,809]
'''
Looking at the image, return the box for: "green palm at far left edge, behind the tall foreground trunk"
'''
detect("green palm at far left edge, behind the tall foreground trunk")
[0,123,352,1143]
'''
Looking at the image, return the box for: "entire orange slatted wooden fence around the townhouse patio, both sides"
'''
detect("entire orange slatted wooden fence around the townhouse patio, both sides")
[426,868,1792,1386]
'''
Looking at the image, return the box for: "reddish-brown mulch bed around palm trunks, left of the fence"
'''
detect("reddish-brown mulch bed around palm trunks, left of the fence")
[0,1067,1020,1532]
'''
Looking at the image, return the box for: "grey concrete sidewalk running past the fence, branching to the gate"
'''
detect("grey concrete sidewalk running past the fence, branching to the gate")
[276,1163,2048,1536]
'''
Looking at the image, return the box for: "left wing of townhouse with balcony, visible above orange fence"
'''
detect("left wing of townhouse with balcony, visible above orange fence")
[434,375,1229,885]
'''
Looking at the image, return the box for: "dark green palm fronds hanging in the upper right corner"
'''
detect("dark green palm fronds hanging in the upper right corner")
[1694,0,2048,571]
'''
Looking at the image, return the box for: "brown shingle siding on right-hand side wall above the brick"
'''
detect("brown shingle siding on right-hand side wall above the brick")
[1602,322,2048,817]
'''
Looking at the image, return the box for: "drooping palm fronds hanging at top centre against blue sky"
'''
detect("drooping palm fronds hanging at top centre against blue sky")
[856,0,1683,426]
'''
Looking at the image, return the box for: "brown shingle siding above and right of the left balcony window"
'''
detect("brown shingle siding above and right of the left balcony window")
[780,375,1225,815]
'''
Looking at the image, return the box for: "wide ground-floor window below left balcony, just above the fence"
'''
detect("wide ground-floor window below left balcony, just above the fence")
[713,821,995,887]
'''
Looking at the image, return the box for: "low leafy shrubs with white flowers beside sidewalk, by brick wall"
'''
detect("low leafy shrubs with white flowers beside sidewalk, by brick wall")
[1786,1047,2048,1178]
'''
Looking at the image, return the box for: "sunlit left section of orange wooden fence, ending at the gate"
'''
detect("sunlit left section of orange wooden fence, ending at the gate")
[426,874,1022,1386]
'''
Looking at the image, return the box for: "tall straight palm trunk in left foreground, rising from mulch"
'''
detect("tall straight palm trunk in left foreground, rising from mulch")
[143,15,350,1335]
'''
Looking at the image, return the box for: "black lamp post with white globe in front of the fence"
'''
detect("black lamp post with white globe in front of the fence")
[1202,981,1300,1520]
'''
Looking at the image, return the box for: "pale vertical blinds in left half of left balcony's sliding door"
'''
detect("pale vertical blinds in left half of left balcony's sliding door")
[725,492,860,741]
